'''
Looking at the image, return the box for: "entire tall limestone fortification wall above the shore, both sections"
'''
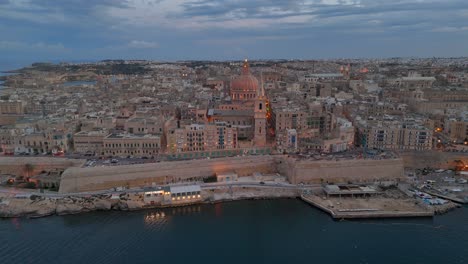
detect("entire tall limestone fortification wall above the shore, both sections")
[60,155,403,193]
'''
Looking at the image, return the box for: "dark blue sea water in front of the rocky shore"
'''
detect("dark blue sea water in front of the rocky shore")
[0,199,468,264]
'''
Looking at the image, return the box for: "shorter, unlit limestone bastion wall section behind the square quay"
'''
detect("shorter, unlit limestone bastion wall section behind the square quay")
[286,159,403,184]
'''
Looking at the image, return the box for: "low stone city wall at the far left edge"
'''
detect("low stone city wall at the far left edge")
[0,157,85,176]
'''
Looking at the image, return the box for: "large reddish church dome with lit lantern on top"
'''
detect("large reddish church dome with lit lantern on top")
[231,60,258,100]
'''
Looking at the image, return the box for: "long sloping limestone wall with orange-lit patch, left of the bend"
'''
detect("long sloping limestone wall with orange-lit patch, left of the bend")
[60,156,276,193]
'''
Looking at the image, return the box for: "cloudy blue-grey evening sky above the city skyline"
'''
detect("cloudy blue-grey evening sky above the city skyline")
[0,0,468,64]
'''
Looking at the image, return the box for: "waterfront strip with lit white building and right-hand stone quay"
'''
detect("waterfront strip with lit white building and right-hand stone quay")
[0,178,459,219]
